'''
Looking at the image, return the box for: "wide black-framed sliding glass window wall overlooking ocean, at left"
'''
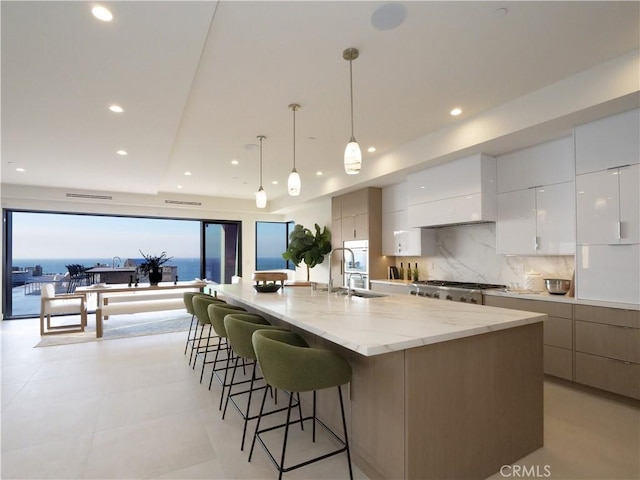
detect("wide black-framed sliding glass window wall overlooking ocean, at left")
[3,210,241,318]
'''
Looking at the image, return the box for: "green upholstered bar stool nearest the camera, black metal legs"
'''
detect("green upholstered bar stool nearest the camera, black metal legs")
[249,330,353,479]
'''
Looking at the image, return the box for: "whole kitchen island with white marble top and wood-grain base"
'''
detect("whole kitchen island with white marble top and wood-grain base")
[208,282,546,479]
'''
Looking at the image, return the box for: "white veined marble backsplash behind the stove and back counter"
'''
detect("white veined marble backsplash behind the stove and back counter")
[396,223,575,285]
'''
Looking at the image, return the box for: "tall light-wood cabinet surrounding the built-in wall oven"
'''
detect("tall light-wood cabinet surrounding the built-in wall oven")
[331,188,389,288]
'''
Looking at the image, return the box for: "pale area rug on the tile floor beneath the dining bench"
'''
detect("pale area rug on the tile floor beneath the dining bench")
[35,310,191,347]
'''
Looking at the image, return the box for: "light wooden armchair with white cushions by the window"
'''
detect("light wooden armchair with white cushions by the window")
[40,283,87,335]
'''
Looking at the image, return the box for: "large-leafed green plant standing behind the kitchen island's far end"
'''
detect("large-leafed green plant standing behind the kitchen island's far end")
[282,223,331,282]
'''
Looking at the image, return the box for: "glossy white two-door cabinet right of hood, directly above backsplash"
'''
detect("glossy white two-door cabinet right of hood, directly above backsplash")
[496,182,575,255]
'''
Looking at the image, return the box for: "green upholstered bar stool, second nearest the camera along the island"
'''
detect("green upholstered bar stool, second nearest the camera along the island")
[222,313,302,450]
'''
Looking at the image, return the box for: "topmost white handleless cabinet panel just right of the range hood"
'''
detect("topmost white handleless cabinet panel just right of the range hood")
[496,136,575,193]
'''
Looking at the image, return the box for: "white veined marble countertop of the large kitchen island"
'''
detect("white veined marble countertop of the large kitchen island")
[208,282,546,356]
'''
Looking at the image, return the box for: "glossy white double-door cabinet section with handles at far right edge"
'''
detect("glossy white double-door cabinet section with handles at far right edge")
[576,165,640,245]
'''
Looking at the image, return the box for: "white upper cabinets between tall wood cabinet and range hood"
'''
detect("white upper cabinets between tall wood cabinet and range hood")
[382,181,435,257]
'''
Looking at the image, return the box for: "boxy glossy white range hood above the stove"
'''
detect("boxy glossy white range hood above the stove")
[407,153,498,228]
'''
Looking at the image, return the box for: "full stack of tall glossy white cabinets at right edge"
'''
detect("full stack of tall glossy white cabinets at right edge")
[574,109,640,303]
